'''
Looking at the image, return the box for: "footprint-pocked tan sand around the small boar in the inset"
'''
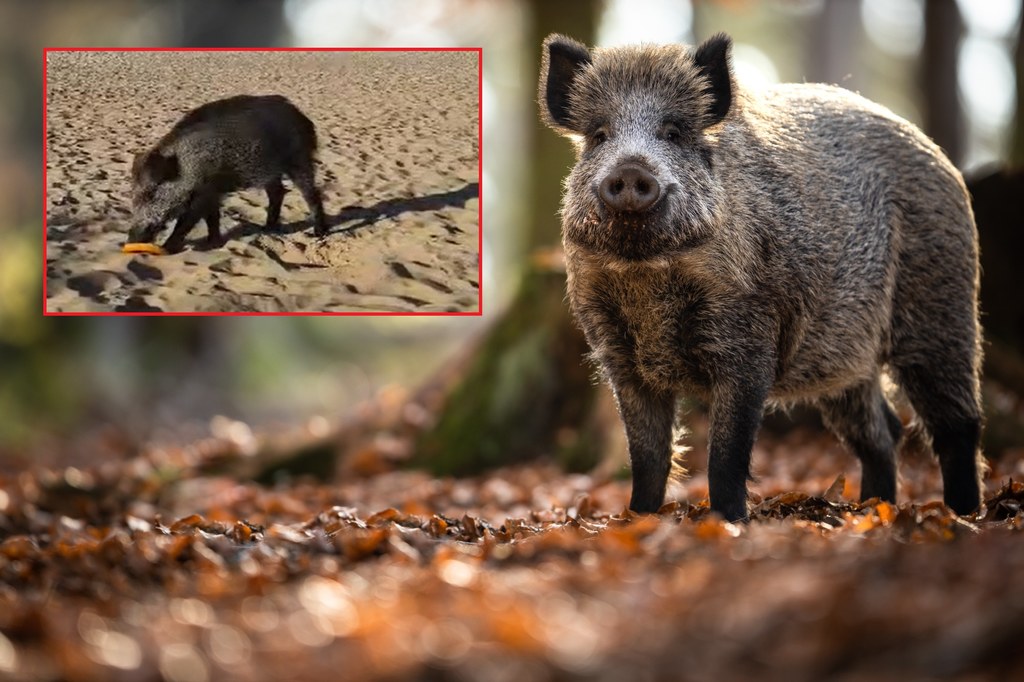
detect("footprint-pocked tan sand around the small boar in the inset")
[45,52,479,312]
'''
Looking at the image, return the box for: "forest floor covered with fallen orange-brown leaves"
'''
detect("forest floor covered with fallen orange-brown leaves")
[0,409,1024,682]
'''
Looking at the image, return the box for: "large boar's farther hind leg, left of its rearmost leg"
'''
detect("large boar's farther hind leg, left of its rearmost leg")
[820,378,903,502]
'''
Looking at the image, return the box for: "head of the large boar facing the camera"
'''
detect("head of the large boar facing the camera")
[539,34,734,260]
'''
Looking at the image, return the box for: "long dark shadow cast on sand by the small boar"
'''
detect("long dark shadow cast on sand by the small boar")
[206,182,480,251]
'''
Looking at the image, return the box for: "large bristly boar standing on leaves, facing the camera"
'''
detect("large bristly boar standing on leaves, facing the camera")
[540,34,983,519]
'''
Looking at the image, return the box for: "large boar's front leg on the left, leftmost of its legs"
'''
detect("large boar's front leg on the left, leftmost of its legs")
[615,383,676,513]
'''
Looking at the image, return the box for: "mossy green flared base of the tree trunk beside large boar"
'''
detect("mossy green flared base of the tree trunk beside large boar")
[413,260,600,474]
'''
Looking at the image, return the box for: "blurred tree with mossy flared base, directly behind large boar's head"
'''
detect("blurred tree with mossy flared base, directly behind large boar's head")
[415,0,603,473]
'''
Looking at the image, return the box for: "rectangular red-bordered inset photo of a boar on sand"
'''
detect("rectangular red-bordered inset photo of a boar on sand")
[43,48,482,314]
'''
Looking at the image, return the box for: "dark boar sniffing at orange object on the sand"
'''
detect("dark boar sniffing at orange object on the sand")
[128,95,327,253]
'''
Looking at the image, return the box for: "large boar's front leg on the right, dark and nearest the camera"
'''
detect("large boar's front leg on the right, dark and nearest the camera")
[708,380,768,521]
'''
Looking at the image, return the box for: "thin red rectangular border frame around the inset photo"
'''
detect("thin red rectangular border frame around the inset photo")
[42,47,483,317]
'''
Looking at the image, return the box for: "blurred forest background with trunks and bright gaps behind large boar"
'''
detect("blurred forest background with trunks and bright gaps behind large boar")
[6,0,1024,467]
